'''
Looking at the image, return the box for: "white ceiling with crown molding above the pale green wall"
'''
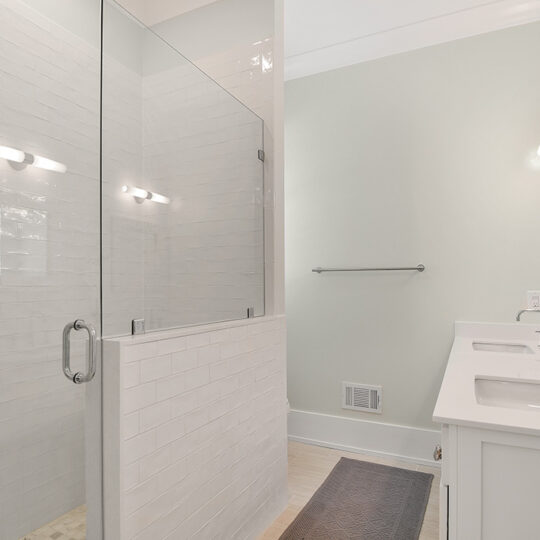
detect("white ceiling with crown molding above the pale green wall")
[285,0,540,79]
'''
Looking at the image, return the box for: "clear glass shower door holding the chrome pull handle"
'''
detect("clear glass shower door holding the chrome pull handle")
[0,0,100,540]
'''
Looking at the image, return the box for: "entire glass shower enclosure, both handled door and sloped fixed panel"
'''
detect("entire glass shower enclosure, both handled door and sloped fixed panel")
[0,0,264,540]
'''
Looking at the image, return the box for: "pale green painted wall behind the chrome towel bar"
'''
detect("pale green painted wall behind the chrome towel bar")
[285,23,540,427]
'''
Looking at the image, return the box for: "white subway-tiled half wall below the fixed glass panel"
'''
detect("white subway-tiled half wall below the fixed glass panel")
[104,317,287,540]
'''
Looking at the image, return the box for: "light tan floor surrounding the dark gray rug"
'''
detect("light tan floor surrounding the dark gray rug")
[259,442,440,540]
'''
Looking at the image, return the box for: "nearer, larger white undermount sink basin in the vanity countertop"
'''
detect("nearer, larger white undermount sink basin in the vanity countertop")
[474,377,540,413]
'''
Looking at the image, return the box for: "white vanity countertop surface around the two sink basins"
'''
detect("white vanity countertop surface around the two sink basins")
[433,322,540,435]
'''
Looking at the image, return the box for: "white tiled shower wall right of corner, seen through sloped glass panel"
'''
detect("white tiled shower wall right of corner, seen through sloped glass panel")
[143,61,264,334]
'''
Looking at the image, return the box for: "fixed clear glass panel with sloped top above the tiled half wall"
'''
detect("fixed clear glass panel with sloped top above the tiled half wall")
[103,1,264,335]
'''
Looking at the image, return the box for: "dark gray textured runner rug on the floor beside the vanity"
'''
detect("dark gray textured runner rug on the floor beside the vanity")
[280,458,433,540]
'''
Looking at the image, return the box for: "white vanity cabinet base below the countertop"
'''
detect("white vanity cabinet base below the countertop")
[440,424,540,540]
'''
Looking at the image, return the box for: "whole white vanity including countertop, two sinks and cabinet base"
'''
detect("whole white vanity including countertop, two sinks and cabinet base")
[433,322,540,540]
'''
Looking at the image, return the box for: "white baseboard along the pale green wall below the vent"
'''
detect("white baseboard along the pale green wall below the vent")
[288,409,441,466]
